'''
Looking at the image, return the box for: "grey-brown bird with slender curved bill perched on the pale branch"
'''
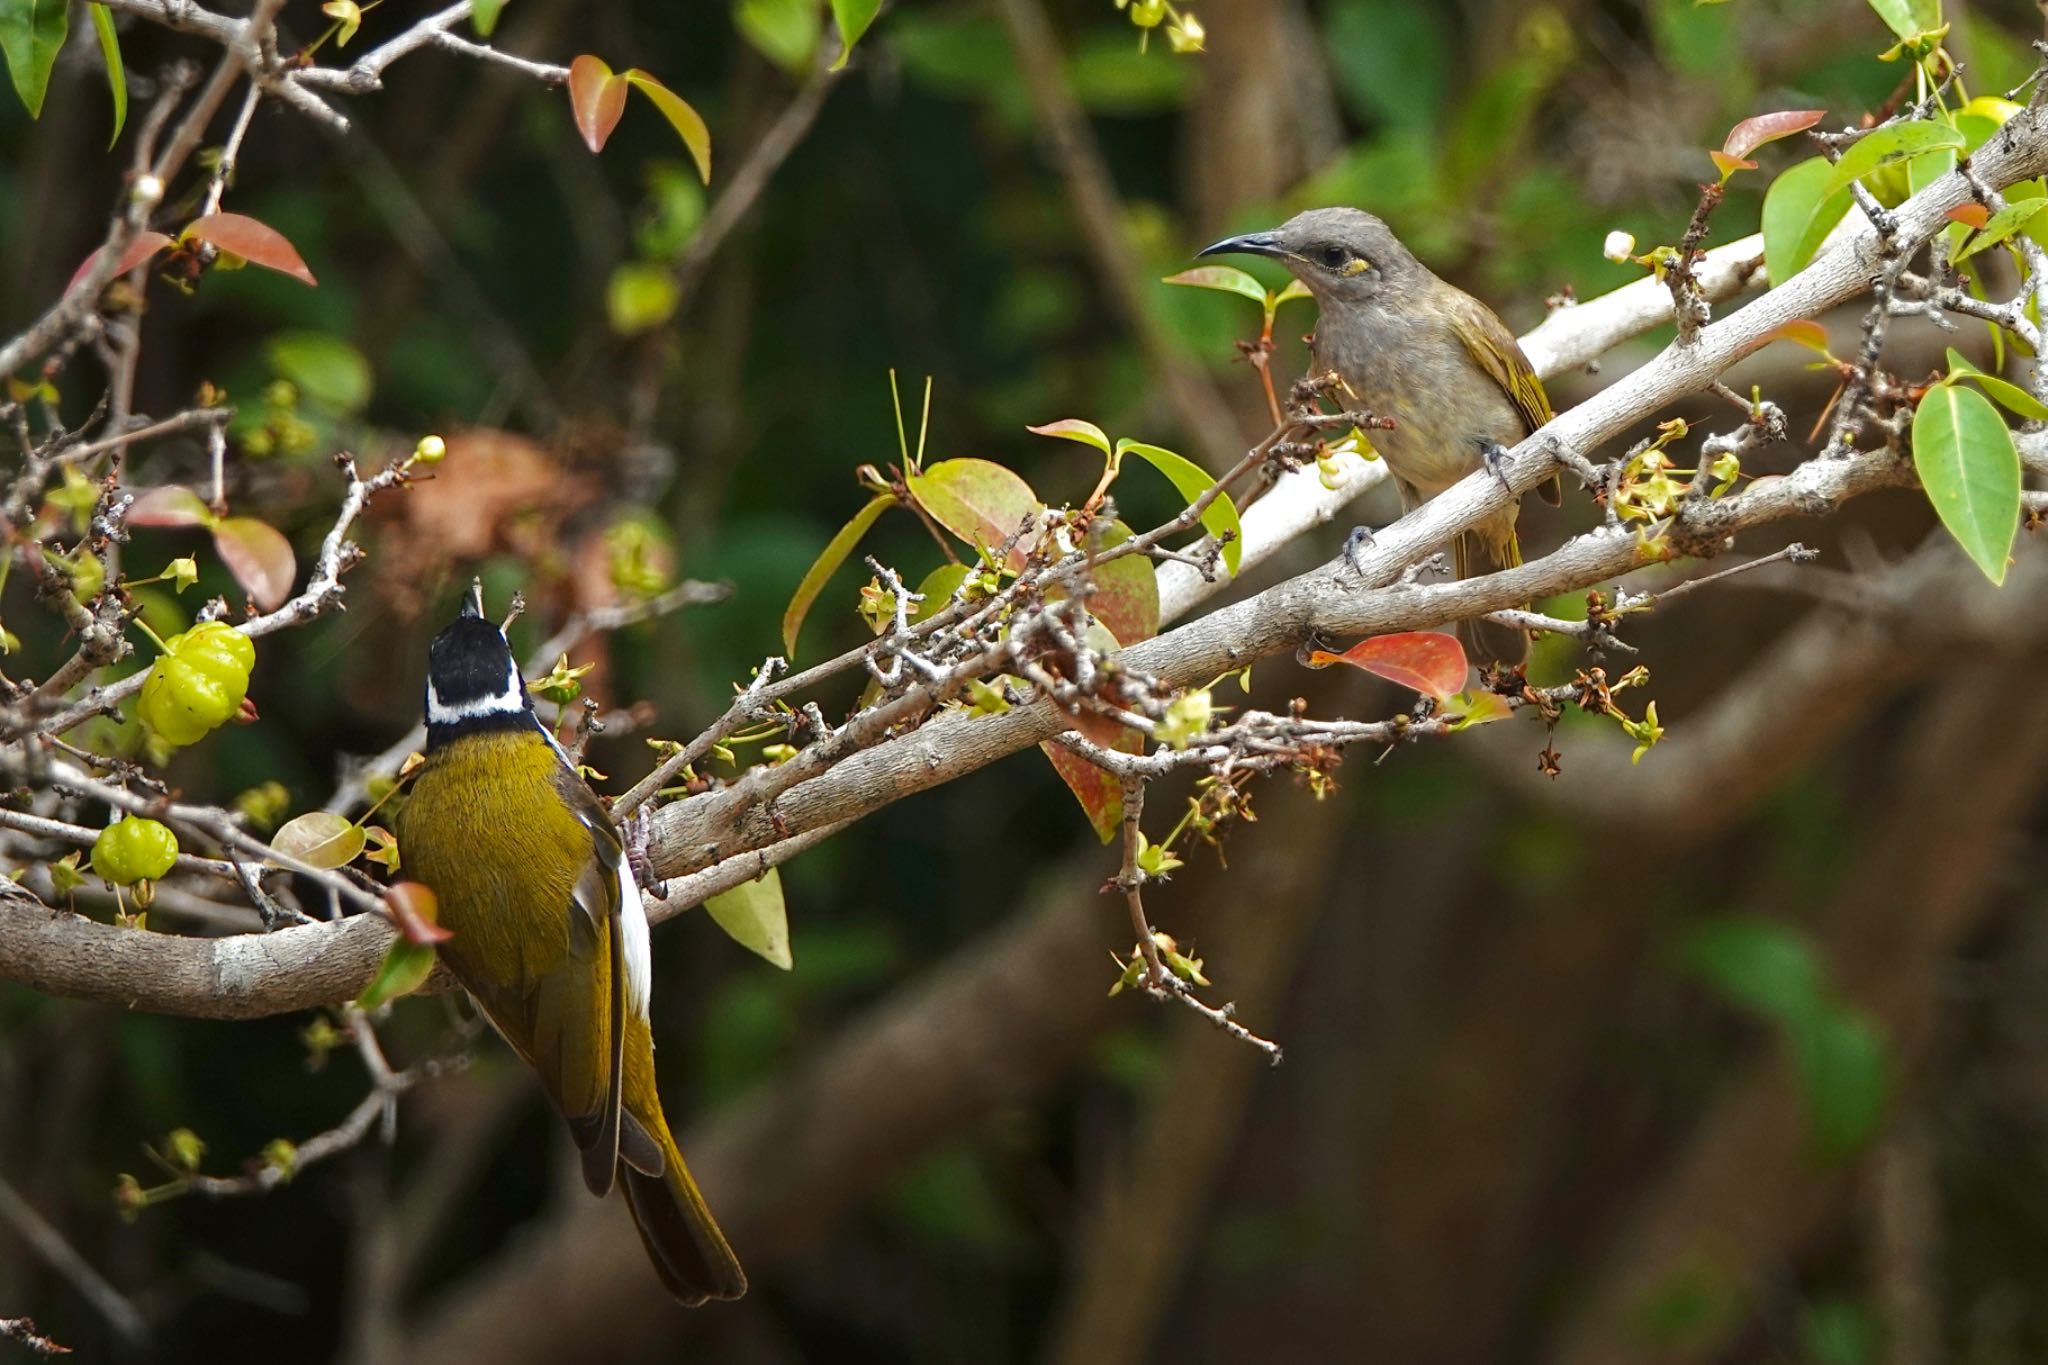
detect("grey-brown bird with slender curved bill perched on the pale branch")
[1198,209,1559,663]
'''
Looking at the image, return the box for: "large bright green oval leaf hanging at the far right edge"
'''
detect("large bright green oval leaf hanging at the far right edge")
[1913,385,2019,583]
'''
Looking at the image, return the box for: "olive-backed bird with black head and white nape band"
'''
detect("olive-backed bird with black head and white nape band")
[397,587,748,1304]
